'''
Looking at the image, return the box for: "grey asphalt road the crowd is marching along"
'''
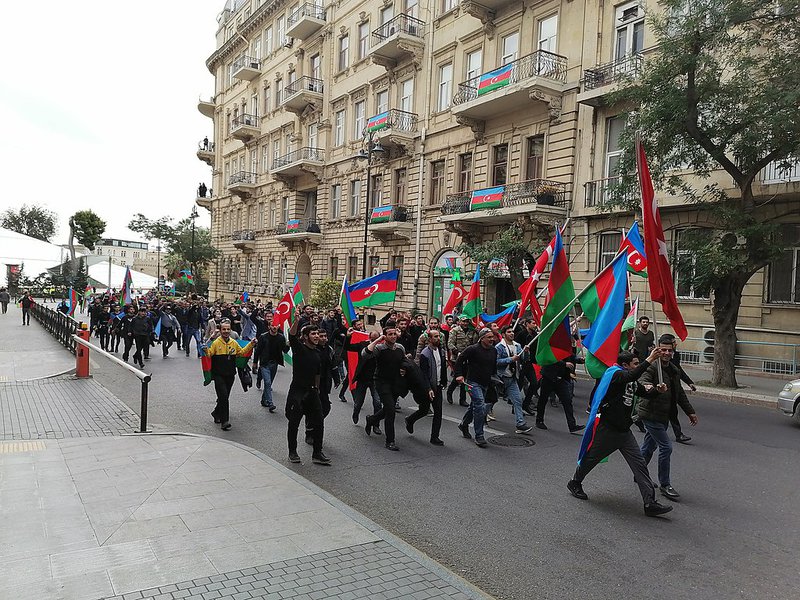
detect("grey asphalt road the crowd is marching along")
[93,349,800,600]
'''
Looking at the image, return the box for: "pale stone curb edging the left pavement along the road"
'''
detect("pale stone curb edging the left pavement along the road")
[128,431,496,600]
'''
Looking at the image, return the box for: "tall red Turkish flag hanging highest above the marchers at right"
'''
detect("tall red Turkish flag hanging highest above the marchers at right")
[636,140,688,340]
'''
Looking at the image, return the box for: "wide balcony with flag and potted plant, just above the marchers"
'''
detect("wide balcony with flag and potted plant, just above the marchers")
[439,179,567,225]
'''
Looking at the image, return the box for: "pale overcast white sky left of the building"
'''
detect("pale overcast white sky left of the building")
[0,0,225,243]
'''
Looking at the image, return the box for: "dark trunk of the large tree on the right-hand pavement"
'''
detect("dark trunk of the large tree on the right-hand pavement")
[711,273,749,388]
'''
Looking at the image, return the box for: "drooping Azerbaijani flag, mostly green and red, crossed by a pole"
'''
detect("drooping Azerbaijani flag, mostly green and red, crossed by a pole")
[536,231,575,366]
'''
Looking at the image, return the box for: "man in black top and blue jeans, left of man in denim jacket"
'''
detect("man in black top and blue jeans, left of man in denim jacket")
[453,327,497,448]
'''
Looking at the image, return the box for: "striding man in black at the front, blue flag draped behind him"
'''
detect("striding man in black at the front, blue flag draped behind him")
[567,349,672,517]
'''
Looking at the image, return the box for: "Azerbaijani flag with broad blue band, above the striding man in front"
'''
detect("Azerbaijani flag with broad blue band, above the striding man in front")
[581,254,628,379]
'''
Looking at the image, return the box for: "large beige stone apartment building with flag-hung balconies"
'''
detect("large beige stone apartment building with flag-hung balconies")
[198,0,800,366]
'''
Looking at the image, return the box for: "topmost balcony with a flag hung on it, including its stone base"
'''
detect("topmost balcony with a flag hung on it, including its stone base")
[450,50,567,126]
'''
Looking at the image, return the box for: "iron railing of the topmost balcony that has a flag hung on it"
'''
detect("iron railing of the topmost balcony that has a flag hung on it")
[453,50,567,104]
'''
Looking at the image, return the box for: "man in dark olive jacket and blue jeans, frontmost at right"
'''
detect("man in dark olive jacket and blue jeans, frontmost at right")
[638,334,698,500]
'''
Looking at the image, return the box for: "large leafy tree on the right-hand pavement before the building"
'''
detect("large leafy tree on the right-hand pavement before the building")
[608,0,800,387]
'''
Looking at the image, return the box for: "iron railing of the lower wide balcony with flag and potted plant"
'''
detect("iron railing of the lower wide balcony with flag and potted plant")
[442,179,567,215]
